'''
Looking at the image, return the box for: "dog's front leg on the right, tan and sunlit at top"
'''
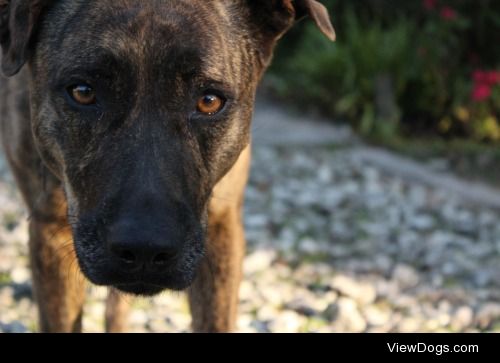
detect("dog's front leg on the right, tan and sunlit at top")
[189,147,250,332]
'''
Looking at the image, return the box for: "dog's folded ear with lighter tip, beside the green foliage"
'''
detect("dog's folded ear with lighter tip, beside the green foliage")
[245,0,335,60]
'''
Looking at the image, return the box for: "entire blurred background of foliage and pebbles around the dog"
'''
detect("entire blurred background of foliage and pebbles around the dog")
[0,0,500,332]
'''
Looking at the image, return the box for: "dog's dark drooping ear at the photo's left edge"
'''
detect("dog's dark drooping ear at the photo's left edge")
[0,0,52,76]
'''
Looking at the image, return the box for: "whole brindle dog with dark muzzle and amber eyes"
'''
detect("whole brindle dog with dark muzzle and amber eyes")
[0,0,334,332]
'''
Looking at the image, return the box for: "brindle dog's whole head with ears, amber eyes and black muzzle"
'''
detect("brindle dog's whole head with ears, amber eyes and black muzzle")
[0,0,334,294]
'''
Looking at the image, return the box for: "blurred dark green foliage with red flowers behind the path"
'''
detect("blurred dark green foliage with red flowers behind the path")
[269,0,500,141]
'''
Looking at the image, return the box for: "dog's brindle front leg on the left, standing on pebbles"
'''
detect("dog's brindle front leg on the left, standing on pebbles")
[29,185,86,332]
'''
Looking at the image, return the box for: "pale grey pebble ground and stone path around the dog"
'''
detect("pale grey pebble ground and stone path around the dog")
[0,103,500,332]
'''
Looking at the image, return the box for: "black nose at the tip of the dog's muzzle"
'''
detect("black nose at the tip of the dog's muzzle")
[109,241,177,271]
